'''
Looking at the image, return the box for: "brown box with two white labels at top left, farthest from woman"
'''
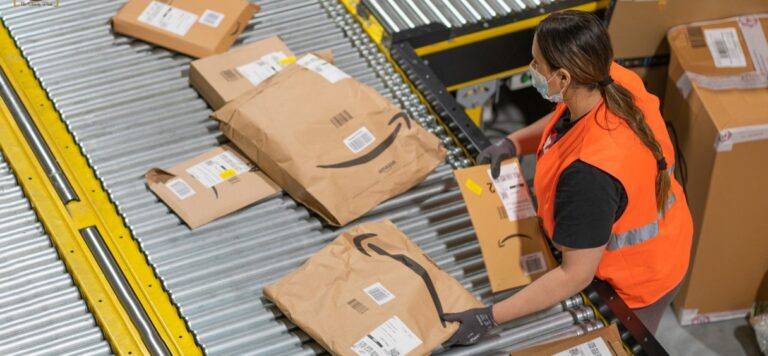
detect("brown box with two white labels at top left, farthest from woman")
[112,0,259,57]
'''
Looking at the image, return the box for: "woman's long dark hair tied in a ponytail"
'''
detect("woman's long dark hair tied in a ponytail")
[536,10,671,212]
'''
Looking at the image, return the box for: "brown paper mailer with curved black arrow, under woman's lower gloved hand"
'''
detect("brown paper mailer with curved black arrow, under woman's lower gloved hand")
[264,220,481,355]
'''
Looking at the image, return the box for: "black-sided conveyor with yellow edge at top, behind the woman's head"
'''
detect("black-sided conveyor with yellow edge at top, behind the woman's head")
[342,0,608,91]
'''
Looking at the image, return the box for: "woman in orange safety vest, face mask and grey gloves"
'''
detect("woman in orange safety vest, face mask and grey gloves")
[445,11,693,345]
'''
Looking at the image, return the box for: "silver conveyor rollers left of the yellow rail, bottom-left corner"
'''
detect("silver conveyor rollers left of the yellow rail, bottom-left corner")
[0,155,112,356]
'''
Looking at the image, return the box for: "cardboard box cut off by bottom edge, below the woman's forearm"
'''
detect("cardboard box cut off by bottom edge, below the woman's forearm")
[511,324,630,356]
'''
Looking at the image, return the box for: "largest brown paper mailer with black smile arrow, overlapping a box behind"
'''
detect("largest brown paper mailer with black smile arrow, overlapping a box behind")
[213,54,445,226]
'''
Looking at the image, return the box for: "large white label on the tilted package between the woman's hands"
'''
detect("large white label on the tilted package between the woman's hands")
[488,163,536,221]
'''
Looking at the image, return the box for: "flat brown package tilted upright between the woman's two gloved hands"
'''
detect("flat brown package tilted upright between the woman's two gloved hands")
[453,159,557,292]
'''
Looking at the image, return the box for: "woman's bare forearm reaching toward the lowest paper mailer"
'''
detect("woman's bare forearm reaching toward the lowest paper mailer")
[493,245,605,324]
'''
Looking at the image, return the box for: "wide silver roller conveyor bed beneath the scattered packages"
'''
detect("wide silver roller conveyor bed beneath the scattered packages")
[0,0,600,355]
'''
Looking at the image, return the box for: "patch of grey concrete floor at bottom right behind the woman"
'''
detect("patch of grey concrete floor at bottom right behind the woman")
[656,308,762,356]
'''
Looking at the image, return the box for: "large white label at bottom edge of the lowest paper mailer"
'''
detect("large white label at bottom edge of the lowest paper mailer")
[352,316,422,356]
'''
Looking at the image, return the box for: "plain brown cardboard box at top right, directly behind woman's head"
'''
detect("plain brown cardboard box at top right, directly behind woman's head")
[608,0,768,58]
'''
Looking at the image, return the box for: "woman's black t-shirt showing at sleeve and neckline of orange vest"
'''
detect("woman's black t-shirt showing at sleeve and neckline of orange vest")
[545,110,627,248]
